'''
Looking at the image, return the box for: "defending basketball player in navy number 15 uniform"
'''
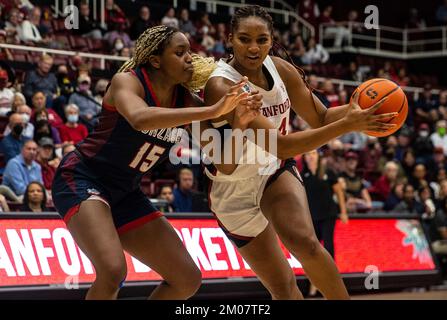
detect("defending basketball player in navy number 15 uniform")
[52,26,260,299]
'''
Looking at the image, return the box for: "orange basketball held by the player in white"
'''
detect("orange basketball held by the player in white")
[351,78,408,137]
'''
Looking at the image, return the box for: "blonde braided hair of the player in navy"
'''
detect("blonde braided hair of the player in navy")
[118,26,216,91]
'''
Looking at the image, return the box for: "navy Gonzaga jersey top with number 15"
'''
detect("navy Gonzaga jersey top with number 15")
[76,67,190,188]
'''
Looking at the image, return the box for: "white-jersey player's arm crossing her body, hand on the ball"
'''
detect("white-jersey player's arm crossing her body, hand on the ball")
[205,77,400,159]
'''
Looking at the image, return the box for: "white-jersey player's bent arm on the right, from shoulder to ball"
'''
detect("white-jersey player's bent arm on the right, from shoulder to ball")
[272,57,349,128]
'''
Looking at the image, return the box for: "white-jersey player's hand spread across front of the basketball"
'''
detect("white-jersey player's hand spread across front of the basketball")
[344,92,399,132]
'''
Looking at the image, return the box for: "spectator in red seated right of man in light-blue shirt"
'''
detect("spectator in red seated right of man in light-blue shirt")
[36,137,60,190]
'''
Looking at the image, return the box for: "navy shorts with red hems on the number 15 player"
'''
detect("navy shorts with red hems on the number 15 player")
[52,151,163,234]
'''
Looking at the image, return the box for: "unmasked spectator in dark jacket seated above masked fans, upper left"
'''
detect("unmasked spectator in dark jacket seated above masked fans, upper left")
[23,54,58,106]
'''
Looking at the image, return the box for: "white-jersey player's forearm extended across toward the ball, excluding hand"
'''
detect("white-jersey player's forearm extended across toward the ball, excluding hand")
[277,119,351,159]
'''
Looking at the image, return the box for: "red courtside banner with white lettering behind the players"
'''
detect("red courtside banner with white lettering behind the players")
[0,219,435,287]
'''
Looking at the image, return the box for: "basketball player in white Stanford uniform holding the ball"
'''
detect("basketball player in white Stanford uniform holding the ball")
[201,6,396,299]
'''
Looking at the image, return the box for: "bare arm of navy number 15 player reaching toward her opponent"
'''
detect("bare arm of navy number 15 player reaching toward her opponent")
[104,73,251,130]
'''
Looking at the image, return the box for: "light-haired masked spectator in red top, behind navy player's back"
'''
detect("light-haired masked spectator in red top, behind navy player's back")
[58,104,88,144]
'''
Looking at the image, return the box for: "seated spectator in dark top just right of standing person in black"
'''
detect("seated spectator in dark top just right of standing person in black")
[341,152,372,212]
